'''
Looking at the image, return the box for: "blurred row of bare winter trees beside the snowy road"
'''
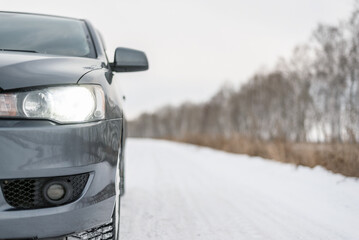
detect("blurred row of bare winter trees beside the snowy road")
[129,7,359,143]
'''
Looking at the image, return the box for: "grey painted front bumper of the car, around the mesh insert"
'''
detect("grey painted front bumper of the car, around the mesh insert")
[0,119,122,239]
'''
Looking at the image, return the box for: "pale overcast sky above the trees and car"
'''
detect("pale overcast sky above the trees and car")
[0,0,354,119]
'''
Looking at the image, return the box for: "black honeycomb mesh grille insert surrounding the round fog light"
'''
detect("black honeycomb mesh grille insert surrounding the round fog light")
[0,173,89,209]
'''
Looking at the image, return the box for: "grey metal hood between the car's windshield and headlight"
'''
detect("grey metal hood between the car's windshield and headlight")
[0,51,104,90]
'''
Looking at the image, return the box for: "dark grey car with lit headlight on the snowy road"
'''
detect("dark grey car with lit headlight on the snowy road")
[0,12,148,240]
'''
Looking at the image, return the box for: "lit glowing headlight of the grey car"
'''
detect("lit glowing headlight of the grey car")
[0,85,105,123]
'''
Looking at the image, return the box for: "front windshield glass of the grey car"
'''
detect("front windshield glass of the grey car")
[0,12,96,58]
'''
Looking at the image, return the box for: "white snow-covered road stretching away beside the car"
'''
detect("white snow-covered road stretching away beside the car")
[121,139,359,240]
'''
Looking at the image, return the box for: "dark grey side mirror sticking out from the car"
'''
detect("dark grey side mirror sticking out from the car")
[111,47,148,72]
